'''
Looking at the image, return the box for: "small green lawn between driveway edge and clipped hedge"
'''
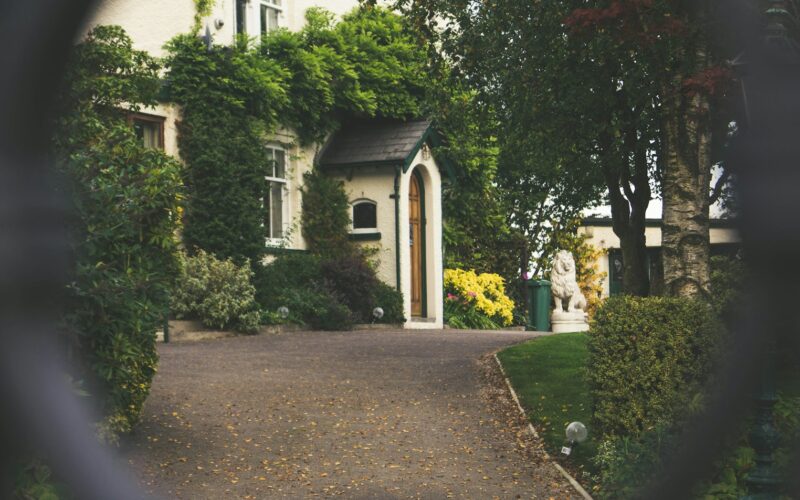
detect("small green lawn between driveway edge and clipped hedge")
[497,333,597,482]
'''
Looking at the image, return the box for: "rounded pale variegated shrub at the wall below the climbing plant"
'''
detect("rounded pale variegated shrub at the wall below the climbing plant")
[172,250,260,333]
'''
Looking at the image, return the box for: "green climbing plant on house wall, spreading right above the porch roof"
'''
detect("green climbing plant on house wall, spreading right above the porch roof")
[166,7,434,263]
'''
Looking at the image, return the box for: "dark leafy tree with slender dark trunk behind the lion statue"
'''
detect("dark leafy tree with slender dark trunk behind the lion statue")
[400,0,659,295]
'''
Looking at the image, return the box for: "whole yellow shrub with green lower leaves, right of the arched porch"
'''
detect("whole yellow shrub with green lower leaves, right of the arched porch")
[444,269,514,329]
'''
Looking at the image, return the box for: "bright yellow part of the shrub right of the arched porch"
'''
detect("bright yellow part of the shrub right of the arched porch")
[444,269,514,326]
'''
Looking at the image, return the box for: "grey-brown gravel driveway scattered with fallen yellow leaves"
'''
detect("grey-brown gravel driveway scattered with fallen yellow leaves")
[124,330,577,499]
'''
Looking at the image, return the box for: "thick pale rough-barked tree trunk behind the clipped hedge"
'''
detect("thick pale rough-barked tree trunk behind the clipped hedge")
[661,41,712,300]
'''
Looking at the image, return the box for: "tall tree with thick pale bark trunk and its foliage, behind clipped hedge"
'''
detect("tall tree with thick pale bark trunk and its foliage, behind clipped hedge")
[571,0,731,298]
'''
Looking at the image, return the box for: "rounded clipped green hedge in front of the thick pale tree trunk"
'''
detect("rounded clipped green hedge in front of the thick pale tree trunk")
[587,296,722,438]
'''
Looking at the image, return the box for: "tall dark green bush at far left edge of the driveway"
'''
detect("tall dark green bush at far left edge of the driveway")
[52,26,182,440]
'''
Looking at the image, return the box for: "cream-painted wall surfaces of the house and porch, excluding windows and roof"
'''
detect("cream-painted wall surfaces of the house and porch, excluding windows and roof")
[84,0,444,328]
